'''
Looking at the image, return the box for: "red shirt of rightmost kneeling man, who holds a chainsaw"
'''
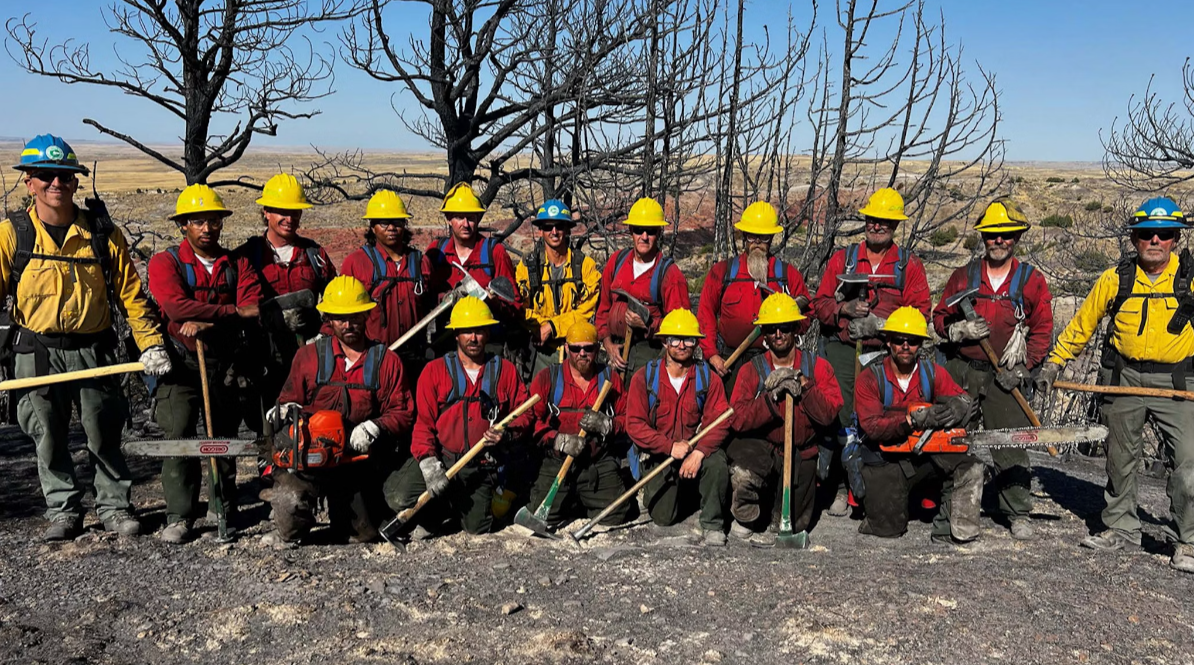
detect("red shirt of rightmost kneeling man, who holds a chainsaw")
[854,357,962,443]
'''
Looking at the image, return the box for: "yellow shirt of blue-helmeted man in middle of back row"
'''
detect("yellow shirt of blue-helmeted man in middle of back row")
[515,250,601,339]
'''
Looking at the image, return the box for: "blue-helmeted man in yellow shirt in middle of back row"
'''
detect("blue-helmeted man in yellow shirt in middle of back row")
[515,199,601,376]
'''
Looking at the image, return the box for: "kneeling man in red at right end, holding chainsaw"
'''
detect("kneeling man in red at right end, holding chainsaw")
[843,307,983,544]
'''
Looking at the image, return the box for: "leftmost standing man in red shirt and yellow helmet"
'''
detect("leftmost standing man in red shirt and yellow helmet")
[149,185,261,543]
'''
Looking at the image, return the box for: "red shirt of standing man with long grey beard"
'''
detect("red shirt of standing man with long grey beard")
[696,254,812,358]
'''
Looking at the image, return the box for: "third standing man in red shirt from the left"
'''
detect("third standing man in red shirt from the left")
[340,190,435,367]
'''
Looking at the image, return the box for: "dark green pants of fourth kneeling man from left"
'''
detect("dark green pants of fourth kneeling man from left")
[642,448,730,531]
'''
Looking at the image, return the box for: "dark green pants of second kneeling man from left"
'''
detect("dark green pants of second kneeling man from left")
[383,456,497,534]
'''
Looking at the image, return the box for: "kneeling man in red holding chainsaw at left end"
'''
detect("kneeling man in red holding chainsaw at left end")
[263,276,414,544]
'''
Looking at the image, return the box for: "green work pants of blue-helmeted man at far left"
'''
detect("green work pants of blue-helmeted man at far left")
[14,346,133,519]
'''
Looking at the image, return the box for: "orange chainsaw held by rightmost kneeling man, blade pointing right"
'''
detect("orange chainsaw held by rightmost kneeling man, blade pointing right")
[879,402,1108,454]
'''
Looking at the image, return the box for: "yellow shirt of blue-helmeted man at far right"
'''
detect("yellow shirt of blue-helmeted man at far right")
[1048,254,1194,365]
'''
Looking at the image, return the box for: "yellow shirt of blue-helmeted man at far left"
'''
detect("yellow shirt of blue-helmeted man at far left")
[0,207,165,351]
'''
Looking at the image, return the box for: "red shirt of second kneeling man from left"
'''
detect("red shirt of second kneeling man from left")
[411,356,533,460]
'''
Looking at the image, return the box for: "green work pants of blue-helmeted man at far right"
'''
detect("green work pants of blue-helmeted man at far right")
[1101,368,1194,544]
